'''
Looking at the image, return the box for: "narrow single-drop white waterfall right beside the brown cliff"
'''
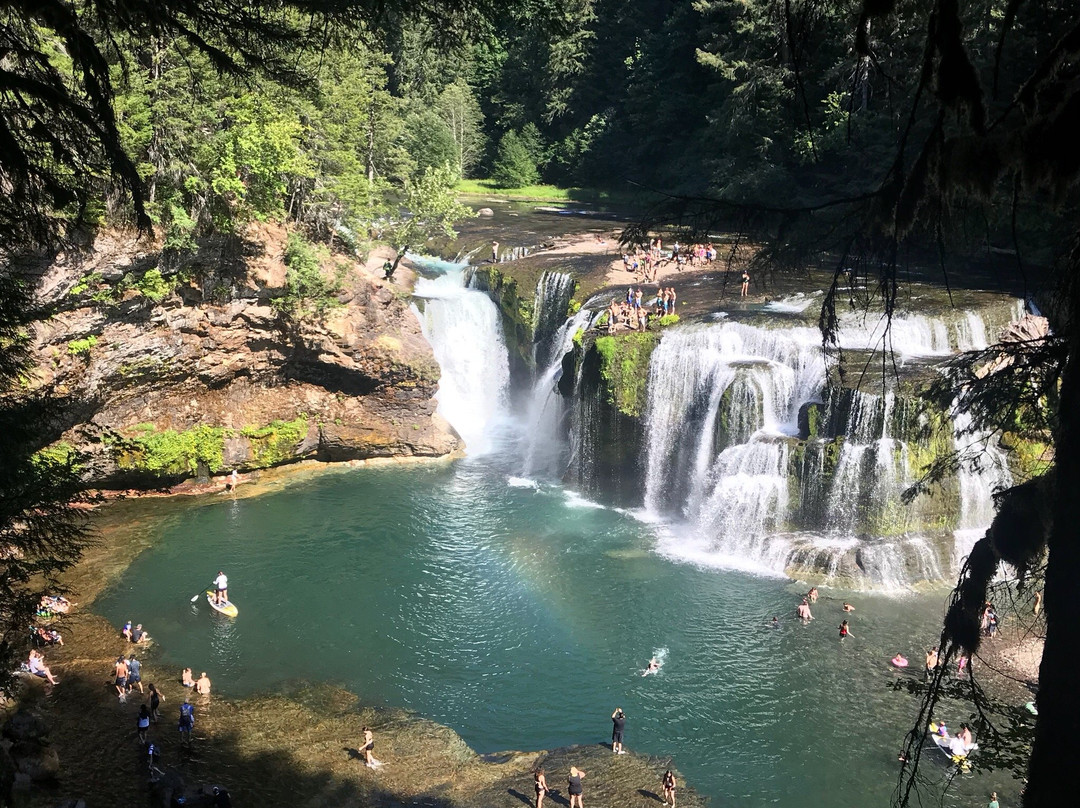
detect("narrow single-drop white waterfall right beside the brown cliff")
[413,266,510,455]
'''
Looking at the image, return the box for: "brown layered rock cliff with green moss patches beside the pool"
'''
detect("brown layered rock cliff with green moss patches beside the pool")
[17,225,460,487]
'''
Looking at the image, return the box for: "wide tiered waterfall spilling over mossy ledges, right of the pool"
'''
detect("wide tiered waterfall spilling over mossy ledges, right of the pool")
[630,313,1008,589]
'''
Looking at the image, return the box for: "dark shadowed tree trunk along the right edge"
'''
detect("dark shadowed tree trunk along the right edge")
[1024,279,1080,808]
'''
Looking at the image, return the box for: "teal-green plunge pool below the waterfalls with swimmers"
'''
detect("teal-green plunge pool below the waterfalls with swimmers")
[96,459,998,808]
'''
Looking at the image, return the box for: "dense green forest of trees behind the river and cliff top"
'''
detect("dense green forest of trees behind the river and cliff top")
[31,0,1069,262]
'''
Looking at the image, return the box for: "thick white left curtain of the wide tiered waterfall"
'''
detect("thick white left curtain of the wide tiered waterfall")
[645,323,825,556]
